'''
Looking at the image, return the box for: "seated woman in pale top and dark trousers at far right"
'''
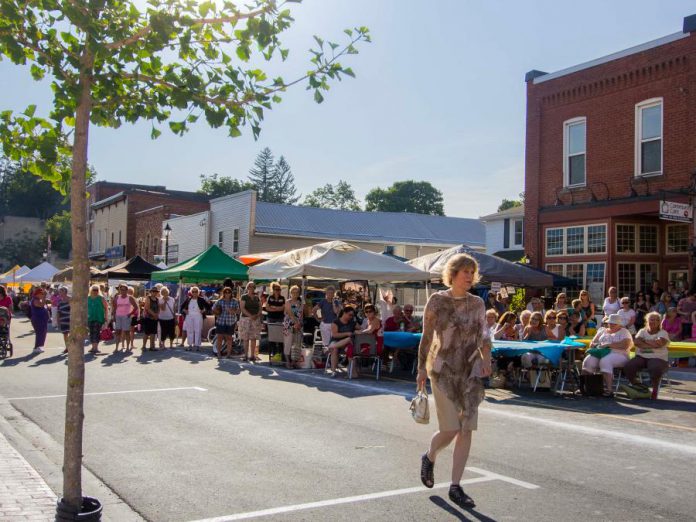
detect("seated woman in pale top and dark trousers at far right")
[624,312,669,399]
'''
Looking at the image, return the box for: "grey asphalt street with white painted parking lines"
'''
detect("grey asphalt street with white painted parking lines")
[0,319,696,521]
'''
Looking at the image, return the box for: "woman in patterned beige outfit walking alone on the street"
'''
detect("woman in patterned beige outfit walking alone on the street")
[416,254,491,508]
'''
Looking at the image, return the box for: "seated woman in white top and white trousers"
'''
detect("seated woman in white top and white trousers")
[582,314,632,397]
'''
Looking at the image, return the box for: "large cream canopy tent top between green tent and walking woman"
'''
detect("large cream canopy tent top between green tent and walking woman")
[249,241,428,282]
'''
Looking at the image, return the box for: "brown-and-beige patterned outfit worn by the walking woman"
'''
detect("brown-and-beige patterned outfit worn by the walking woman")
[418,290,491,431]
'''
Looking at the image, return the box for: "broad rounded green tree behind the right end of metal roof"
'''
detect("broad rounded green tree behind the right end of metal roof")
[365,180,445,216]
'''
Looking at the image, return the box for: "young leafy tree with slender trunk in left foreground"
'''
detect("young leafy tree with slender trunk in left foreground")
[0,0,369,510]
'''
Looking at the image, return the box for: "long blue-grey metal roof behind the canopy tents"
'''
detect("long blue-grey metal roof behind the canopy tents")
[255,201,486,246]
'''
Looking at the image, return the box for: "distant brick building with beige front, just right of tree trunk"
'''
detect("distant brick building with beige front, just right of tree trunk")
[87,181,209,264]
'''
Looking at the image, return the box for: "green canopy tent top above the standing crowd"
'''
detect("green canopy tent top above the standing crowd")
[152,245,247,283]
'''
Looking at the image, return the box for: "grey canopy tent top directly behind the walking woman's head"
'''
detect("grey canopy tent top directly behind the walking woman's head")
[408,245,553,288]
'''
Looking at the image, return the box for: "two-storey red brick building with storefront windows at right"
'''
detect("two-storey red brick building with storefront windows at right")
[524,15,696,303]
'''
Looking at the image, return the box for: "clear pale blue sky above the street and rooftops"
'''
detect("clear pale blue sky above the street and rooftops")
[0,0,696,218]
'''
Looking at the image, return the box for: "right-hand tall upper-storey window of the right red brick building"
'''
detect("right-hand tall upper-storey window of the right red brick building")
[636,98,662,176]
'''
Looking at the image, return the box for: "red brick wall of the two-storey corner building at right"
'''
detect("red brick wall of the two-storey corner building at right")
[525,33,696,284]
